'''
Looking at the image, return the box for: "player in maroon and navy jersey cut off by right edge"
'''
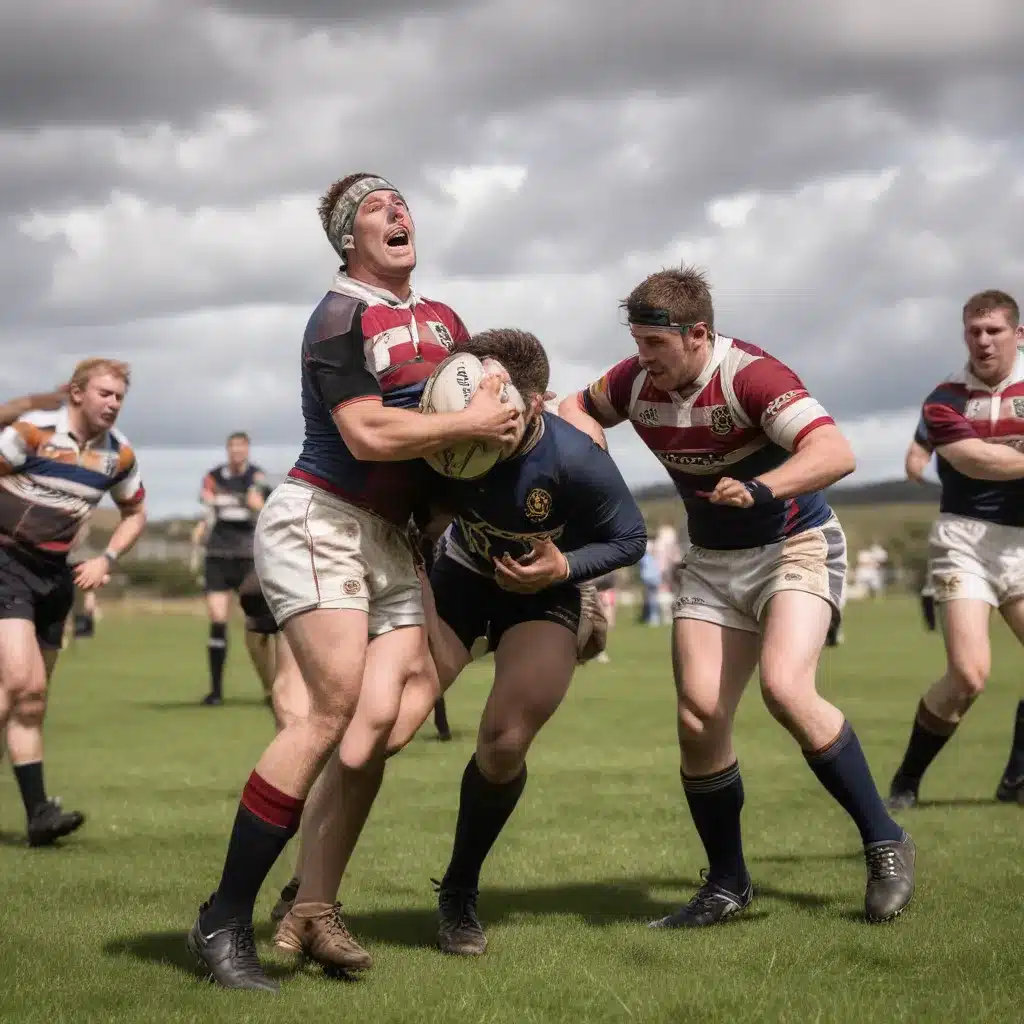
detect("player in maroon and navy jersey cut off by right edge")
[889,290,1024,808]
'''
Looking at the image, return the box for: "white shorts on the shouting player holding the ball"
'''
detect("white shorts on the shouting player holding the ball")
[253,478,424,637]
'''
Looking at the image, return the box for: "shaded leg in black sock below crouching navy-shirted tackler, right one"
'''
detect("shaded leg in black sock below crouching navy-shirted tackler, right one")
[437,621,577,956]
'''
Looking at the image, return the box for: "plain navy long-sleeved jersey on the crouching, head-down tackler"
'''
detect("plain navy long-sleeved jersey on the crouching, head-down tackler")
[438,413,647,582]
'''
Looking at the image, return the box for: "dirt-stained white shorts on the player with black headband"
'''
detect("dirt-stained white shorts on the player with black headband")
[672,516,846,633]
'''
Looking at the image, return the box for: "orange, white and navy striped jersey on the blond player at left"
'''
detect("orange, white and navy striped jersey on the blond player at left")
[0,407,145,560]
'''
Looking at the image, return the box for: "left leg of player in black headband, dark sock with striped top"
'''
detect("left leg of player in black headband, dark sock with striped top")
[650,610,759,928]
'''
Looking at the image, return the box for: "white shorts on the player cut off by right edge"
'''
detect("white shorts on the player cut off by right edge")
[928,513,1024,608]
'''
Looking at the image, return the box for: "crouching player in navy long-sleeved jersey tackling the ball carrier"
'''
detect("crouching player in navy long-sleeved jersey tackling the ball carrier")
[275,330,647,970]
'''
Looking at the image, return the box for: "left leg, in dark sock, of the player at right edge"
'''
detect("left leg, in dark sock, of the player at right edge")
[889,598,993,810]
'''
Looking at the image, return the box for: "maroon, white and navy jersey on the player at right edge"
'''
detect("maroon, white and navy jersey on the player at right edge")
[922,354,1024,526]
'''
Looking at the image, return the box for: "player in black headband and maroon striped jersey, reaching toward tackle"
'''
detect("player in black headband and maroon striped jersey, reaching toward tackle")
[561,268,914,928]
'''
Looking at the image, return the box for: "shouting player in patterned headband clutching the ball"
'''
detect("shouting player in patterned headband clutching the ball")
[188,173,519,991]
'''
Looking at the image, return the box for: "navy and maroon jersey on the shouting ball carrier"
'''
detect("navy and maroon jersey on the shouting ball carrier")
[289,273,469,526]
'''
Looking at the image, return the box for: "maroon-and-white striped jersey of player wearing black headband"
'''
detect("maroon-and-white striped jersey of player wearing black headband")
[582,335,834,549]
